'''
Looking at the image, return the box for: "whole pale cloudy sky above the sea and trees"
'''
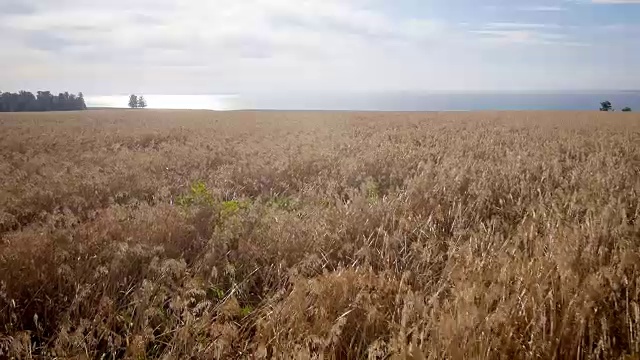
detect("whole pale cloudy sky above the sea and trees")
[0,0,640,94]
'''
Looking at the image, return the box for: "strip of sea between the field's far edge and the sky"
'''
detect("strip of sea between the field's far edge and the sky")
[85,90,640,111]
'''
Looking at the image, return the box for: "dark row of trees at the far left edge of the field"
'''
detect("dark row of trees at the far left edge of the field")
[0,91,87,112]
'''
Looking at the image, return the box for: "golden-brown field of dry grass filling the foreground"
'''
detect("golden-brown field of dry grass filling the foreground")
[0,110,640,359]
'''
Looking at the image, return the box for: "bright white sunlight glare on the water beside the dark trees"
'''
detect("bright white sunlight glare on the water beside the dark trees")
[86,95,242,110]
